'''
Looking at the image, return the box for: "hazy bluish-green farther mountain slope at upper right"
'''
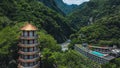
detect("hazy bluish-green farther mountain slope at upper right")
[68,0,119,29]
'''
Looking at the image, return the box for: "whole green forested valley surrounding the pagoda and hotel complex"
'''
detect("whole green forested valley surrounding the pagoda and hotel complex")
[0,0,120,68]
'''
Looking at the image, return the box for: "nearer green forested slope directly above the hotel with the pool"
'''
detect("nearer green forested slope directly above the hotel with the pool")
[78,15,120,47]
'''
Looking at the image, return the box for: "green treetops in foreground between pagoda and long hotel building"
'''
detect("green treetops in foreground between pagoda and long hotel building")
[42,50,100,68]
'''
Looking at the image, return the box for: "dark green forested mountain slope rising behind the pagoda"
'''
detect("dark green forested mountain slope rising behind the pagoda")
[0,0,71,42]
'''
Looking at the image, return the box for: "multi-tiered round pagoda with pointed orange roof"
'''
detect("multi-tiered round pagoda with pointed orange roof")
[18,24,39,68]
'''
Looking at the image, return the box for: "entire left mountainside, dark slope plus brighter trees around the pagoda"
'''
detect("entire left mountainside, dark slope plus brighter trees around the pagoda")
[0,0,72,68]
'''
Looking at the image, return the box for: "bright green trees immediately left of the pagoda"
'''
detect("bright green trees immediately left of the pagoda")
[0,24,22,68]
